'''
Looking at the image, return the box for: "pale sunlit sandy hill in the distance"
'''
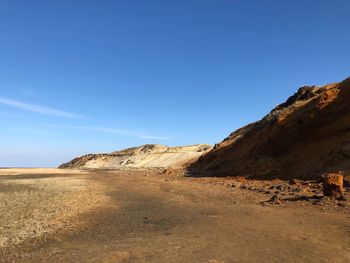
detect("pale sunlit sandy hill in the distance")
[59,144,212,169]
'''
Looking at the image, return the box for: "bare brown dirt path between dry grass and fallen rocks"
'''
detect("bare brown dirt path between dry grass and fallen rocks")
[0,172,350,263]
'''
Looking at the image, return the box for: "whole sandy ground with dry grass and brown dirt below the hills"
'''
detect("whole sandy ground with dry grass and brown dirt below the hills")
[0,169,350,263]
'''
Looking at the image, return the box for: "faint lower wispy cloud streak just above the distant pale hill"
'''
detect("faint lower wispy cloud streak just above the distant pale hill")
[44,124,171,140]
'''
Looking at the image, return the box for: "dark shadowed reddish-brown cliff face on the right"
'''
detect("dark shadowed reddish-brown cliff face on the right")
[189,78,350,179]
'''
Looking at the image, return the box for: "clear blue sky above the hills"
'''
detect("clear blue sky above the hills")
[0,0,350,166]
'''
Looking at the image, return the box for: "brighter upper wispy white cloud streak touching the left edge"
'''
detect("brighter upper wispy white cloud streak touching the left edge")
[0,97,87,119]
